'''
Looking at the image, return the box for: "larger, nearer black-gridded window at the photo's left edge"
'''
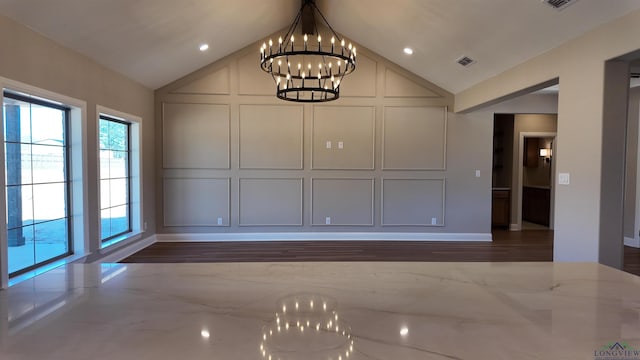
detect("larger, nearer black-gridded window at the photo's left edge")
[2,92,73,276]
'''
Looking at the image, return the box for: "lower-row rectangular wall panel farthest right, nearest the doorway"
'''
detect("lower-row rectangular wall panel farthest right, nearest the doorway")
[381,178,445,226]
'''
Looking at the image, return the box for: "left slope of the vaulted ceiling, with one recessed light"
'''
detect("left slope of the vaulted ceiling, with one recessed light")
[0,0,299,89]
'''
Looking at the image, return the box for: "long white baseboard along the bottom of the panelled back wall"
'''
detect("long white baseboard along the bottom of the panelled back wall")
[155,232,492,242]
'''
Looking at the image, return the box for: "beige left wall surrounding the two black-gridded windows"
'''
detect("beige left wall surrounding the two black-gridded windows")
[0,16,155,252]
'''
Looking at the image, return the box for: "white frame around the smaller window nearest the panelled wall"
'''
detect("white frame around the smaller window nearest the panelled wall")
[95,105,146,252]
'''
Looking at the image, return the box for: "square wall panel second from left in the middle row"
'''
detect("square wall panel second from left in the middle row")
[240,105,304,170]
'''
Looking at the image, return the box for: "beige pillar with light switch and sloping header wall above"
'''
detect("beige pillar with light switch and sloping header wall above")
[455,7,640,261]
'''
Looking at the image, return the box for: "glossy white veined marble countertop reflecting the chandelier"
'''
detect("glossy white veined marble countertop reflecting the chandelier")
[0,262,640,360]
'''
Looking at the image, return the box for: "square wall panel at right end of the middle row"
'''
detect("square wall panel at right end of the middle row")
[382,106,447,170]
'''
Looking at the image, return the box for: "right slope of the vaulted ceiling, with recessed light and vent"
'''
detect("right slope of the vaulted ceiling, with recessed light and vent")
[319,0,640,93]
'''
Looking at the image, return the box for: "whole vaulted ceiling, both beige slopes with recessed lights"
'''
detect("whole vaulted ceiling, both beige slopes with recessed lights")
[0,0,640,93]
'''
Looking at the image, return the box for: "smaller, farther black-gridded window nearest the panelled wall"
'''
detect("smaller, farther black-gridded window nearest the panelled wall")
[99,115,132,242]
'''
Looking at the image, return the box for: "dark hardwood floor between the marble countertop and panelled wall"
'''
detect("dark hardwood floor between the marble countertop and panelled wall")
[122,230,640,275]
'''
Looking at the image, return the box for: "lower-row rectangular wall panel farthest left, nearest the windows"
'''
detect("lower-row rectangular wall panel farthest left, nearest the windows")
[163,178,230,226]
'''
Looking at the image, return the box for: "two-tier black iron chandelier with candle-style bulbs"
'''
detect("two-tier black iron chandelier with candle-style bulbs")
[260,0,356,102]
